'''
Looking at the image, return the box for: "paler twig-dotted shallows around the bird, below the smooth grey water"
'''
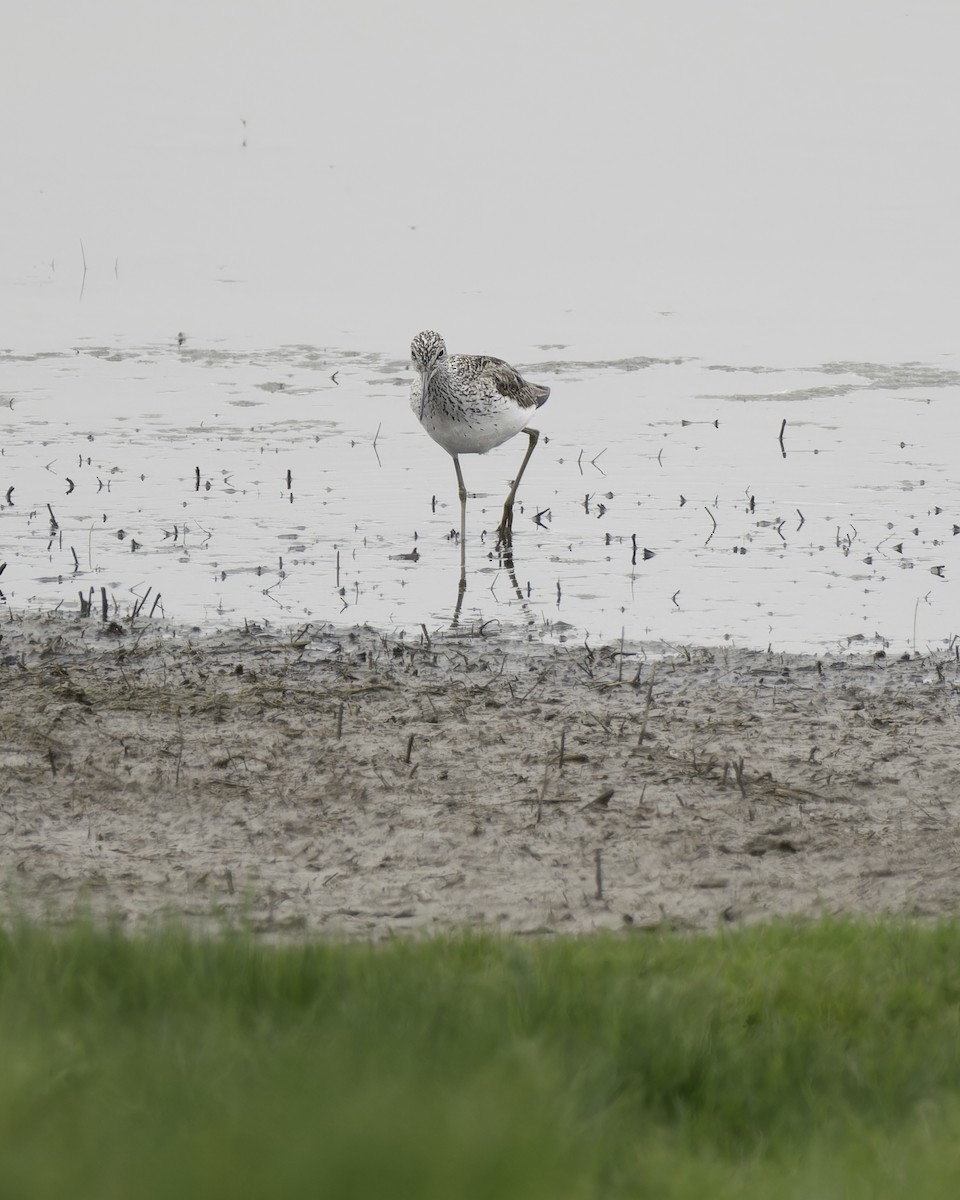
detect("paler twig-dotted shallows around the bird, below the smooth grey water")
[0,341,960,650]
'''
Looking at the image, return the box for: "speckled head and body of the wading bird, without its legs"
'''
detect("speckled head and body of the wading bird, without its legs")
[410,329,550,455]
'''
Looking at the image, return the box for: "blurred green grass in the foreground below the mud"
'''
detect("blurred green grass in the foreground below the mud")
[0,923,960,1200]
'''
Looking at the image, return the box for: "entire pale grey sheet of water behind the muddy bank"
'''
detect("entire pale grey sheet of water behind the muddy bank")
[0,0,960,650]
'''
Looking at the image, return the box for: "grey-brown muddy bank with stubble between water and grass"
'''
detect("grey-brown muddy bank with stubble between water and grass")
[0,613,960,938]
